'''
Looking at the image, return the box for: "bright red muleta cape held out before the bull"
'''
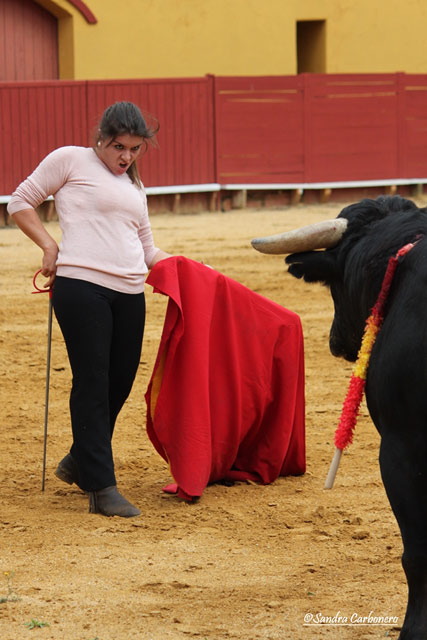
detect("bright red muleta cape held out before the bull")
[145,257,305,500]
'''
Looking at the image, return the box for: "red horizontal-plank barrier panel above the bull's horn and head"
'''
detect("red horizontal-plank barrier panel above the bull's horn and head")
[305,74,403,182]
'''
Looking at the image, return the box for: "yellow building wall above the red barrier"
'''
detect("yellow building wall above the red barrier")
[37,0,427,80]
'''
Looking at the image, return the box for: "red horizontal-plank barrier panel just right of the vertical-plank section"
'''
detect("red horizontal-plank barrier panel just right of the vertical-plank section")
[215,76,305,184]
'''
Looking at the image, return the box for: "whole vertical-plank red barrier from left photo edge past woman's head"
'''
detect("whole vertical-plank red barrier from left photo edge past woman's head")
[0,77,215,194]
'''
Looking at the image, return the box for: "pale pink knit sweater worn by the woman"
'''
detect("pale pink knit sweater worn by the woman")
[8,147,158,293]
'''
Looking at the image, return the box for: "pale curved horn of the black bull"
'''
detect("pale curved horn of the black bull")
[251,218,347,254]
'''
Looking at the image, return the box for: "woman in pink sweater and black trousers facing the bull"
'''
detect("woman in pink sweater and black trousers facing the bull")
[8,102,169,517]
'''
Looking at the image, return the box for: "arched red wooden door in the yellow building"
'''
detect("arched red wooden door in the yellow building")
[0,0,58,81]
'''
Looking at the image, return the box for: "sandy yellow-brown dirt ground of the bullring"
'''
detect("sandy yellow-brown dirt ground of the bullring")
[0,204,418,640]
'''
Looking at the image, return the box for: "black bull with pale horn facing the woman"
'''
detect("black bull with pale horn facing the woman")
[252,196,427,640]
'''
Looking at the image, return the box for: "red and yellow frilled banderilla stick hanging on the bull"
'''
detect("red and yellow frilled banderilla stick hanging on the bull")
[325,241,417,489]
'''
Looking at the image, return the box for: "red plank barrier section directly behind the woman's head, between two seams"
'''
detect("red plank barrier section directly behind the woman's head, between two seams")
[88,78,215,186]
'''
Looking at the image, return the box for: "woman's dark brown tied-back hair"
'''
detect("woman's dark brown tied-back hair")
[95,102,159,187]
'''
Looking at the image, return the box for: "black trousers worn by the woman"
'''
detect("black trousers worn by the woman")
[52,276,145,491]
